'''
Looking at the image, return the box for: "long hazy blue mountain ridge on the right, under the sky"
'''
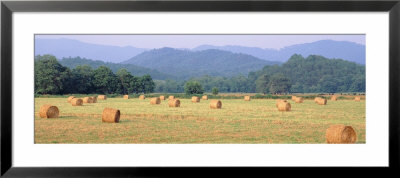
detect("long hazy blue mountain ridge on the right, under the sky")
[192,40,366,64]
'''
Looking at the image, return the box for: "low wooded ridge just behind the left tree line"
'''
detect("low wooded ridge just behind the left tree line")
[60,57,176,80]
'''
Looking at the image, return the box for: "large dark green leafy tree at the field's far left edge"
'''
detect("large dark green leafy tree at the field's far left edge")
[34,55,71,94]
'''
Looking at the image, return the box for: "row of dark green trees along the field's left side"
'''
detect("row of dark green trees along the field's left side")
[34,55,155,94]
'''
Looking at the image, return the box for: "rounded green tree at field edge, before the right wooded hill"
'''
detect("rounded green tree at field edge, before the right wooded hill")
[269,74,291,94]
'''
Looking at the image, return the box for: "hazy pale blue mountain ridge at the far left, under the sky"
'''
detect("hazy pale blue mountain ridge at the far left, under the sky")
[35,39,146,63]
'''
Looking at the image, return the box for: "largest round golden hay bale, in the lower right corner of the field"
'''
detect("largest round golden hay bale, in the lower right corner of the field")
[326,124,357,143]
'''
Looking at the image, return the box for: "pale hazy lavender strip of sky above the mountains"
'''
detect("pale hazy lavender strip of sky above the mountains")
[35,34,365,49]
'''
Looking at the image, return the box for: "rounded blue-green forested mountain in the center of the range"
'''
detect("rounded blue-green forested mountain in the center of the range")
[122,48,279,79]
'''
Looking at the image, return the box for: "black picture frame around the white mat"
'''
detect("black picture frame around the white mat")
[0,0,400,177]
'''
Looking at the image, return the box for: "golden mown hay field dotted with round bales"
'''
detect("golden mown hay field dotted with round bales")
[35,97,366,144]
